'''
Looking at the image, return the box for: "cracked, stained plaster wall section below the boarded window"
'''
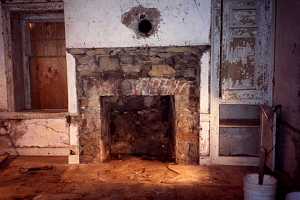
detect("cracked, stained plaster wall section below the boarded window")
[0,118,70,155]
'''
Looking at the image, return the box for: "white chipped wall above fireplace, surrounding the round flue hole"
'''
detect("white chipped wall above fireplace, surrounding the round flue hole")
[64,0,211,48]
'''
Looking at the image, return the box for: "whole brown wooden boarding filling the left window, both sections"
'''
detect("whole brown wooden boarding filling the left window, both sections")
[28,22,68,109]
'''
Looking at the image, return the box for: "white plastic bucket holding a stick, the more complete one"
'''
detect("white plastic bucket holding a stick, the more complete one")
[244,174,277,200]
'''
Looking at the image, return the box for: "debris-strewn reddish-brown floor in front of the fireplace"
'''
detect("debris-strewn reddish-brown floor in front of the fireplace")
[0,157,255,200]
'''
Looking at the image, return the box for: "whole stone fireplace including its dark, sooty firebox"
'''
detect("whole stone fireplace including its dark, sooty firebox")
[69,46,207,164]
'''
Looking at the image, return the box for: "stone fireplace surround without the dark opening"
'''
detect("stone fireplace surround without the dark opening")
[68,46,207,164]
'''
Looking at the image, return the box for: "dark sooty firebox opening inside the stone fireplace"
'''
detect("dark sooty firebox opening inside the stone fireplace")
[101,96,175,162]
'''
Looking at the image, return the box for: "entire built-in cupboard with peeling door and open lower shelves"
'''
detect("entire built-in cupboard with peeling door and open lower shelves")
[211,0,274,165]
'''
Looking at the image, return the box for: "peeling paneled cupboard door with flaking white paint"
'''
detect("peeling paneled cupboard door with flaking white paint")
[220,0,264,103]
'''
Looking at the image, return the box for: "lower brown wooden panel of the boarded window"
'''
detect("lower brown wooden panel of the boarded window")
[31,57,68,109]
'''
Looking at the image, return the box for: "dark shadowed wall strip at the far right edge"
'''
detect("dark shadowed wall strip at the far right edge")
[274,0,300,182]
